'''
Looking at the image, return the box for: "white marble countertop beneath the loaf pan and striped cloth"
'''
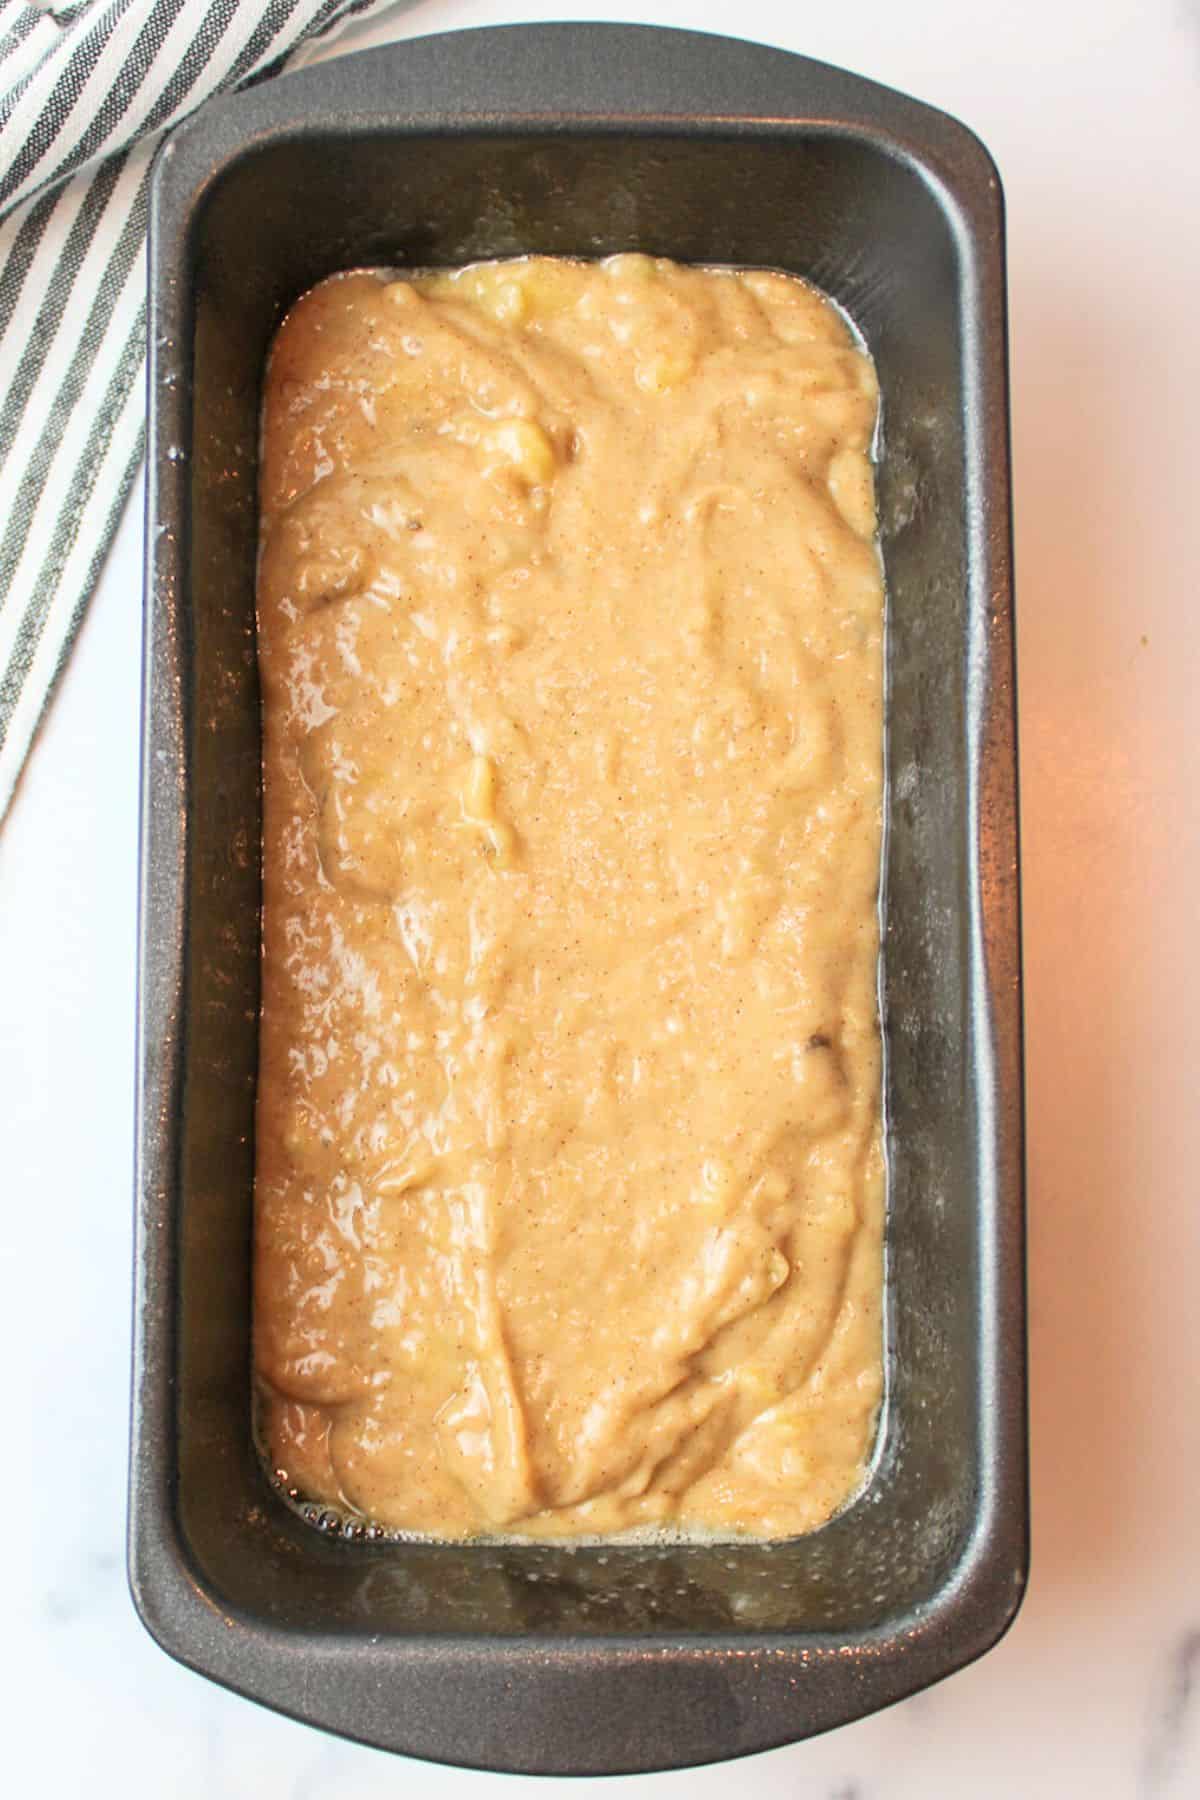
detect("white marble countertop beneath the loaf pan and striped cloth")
[0,0,1200,1800]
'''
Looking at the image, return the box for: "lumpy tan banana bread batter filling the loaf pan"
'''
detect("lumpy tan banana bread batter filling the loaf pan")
[255,256,883,1537]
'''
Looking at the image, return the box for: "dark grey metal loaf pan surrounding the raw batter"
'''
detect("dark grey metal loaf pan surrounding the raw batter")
[130,25,1027,1773]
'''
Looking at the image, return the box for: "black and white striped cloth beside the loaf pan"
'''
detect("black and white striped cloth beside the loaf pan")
[0,0,392,817]
